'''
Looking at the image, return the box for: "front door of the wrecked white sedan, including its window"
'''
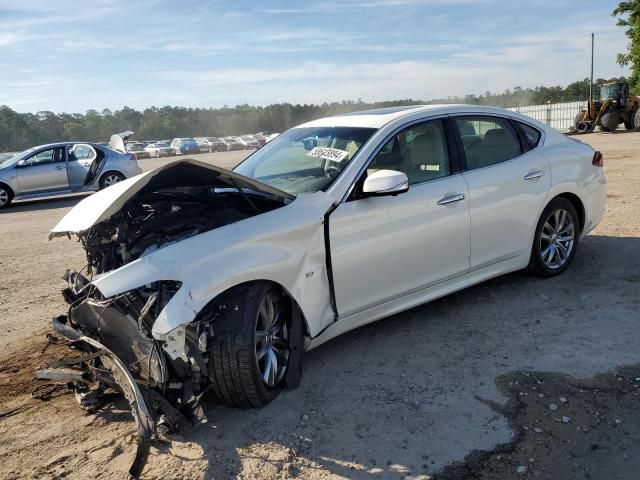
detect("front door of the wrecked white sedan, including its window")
[329,116,470,317]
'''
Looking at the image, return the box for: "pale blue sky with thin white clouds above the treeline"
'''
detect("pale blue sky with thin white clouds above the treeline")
[0,0,629,112]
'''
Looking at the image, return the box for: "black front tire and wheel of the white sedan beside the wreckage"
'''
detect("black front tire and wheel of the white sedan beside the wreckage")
[209,282,302,408]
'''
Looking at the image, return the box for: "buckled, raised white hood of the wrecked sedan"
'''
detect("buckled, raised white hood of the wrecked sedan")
[49,159,295,239]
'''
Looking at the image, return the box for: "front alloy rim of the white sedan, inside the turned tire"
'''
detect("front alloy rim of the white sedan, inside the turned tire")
[256,293,289,388]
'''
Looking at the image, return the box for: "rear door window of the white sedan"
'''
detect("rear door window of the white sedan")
[455,116,522,170]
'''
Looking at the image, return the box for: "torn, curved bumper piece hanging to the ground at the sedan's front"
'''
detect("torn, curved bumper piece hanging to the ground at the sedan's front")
[36,316,166,479]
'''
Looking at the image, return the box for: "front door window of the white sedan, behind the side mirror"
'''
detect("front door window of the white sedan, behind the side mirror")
[367,120,451,185]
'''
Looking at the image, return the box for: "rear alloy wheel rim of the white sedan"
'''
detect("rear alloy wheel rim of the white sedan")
[540,208,576,270]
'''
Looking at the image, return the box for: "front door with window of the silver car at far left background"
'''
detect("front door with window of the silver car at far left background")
[16,147,69,194]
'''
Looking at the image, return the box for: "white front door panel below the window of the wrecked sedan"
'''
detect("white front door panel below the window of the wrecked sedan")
[329,174,469,316]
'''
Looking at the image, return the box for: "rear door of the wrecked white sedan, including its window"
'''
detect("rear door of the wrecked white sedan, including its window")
[453,115,551,270]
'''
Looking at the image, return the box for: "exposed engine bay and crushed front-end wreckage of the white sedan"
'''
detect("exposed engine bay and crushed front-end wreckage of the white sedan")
[37,161,302,477]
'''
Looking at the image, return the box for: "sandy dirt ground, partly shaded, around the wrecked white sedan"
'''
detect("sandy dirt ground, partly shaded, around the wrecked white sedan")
[0,132,640,480]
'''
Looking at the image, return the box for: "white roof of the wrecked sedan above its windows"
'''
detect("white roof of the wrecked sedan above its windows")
[295,104,541,128]
